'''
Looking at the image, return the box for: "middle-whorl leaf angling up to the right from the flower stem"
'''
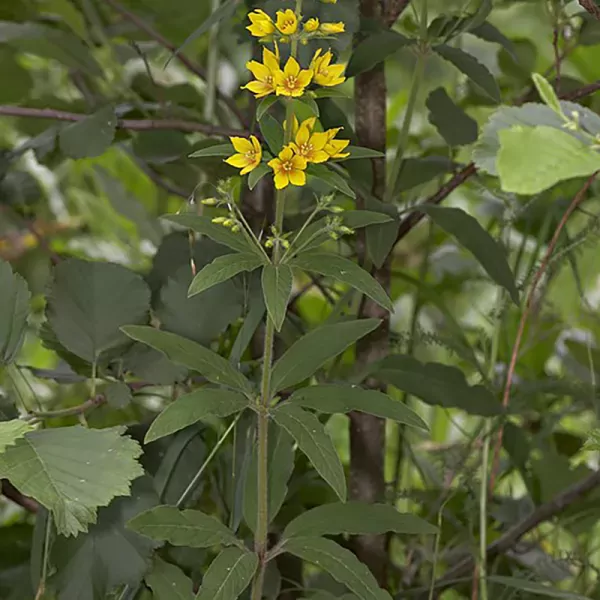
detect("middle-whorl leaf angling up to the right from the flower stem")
[271,319,381,393]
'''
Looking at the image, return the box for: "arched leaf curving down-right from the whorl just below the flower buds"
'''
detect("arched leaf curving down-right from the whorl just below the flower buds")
[289,252,394,312]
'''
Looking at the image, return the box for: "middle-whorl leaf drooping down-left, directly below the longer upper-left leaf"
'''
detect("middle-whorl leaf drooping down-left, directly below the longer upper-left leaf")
[144,387,248,444]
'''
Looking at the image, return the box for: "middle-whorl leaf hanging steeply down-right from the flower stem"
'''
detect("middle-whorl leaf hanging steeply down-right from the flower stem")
[272,403,346,502]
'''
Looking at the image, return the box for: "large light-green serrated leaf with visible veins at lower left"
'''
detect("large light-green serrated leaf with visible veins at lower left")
[0,426,144,536]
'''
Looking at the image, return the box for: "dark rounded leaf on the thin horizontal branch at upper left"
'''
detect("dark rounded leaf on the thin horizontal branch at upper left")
[58,106,117,158]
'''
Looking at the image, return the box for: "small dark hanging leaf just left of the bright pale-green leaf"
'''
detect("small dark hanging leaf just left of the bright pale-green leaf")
[427,87,477,146]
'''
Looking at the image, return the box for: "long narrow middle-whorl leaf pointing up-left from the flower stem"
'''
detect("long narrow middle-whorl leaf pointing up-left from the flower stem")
[122,325,252,394]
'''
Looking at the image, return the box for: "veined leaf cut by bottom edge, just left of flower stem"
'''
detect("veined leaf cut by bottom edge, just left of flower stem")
[196,548,258,600]
